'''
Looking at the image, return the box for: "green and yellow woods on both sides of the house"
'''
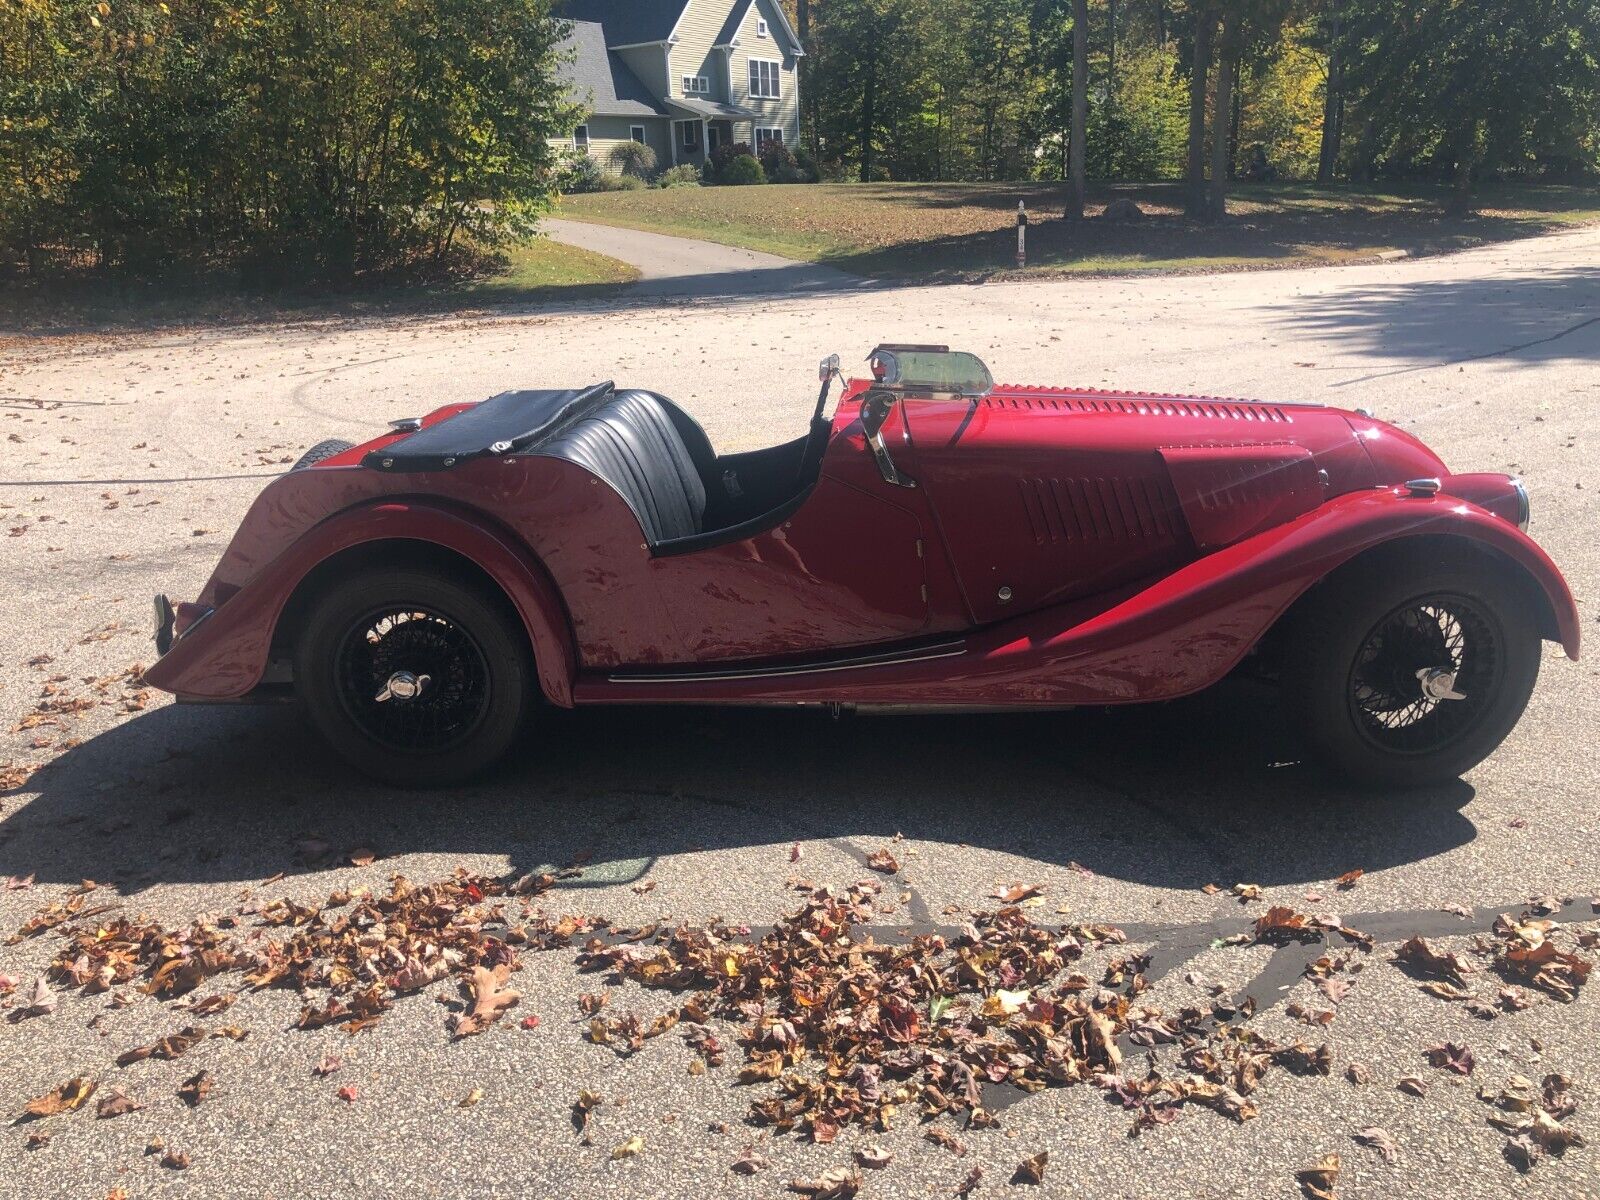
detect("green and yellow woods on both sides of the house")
[0,0,1600,282]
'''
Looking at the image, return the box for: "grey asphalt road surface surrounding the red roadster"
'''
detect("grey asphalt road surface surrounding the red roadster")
[0,230,1600,1198]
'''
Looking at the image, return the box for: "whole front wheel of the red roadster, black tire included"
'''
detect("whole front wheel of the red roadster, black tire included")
[1282,542,1541,787]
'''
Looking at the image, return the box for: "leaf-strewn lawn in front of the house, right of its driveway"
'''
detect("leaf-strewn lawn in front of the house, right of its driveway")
[558,182,1600,278]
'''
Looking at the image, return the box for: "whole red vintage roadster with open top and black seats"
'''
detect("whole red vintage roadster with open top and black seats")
[146,346,1579,786]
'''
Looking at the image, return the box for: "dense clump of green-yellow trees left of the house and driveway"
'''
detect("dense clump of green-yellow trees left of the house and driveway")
[0,0,576,282]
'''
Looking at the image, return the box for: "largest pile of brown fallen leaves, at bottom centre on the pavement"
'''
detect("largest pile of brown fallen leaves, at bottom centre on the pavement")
[579,883,1330,1142]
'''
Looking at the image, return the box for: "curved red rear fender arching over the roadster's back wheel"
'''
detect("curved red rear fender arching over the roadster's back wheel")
[144,498,578,707]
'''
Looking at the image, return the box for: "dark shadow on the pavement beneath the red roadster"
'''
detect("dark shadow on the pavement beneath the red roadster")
[0,683,1475,891]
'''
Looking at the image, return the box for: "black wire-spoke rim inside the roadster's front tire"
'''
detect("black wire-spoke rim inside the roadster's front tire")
[1347,594,1506,755]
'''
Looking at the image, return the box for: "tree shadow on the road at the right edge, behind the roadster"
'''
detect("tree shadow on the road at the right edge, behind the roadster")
[1272,266,1600,366]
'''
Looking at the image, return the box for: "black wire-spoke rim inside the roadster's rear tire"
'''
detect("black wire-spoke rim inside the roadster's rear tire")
[336,605,490,754]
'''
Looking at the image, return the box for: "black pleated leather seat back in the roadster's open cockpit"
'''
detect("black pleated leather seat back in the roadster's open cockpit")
[538,389,706,546]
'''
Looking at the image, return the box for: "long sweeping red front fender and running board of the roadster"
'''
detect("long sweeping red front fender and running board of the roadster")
[574,488,1579,707]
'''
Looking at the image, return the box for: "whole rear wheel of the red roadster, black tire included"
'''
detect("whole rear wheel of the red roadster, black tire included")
[294,568,534,787]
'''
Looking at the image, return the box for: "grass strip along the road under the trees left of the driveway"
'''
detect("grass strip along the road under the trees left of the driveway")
[0,237,638,334]
